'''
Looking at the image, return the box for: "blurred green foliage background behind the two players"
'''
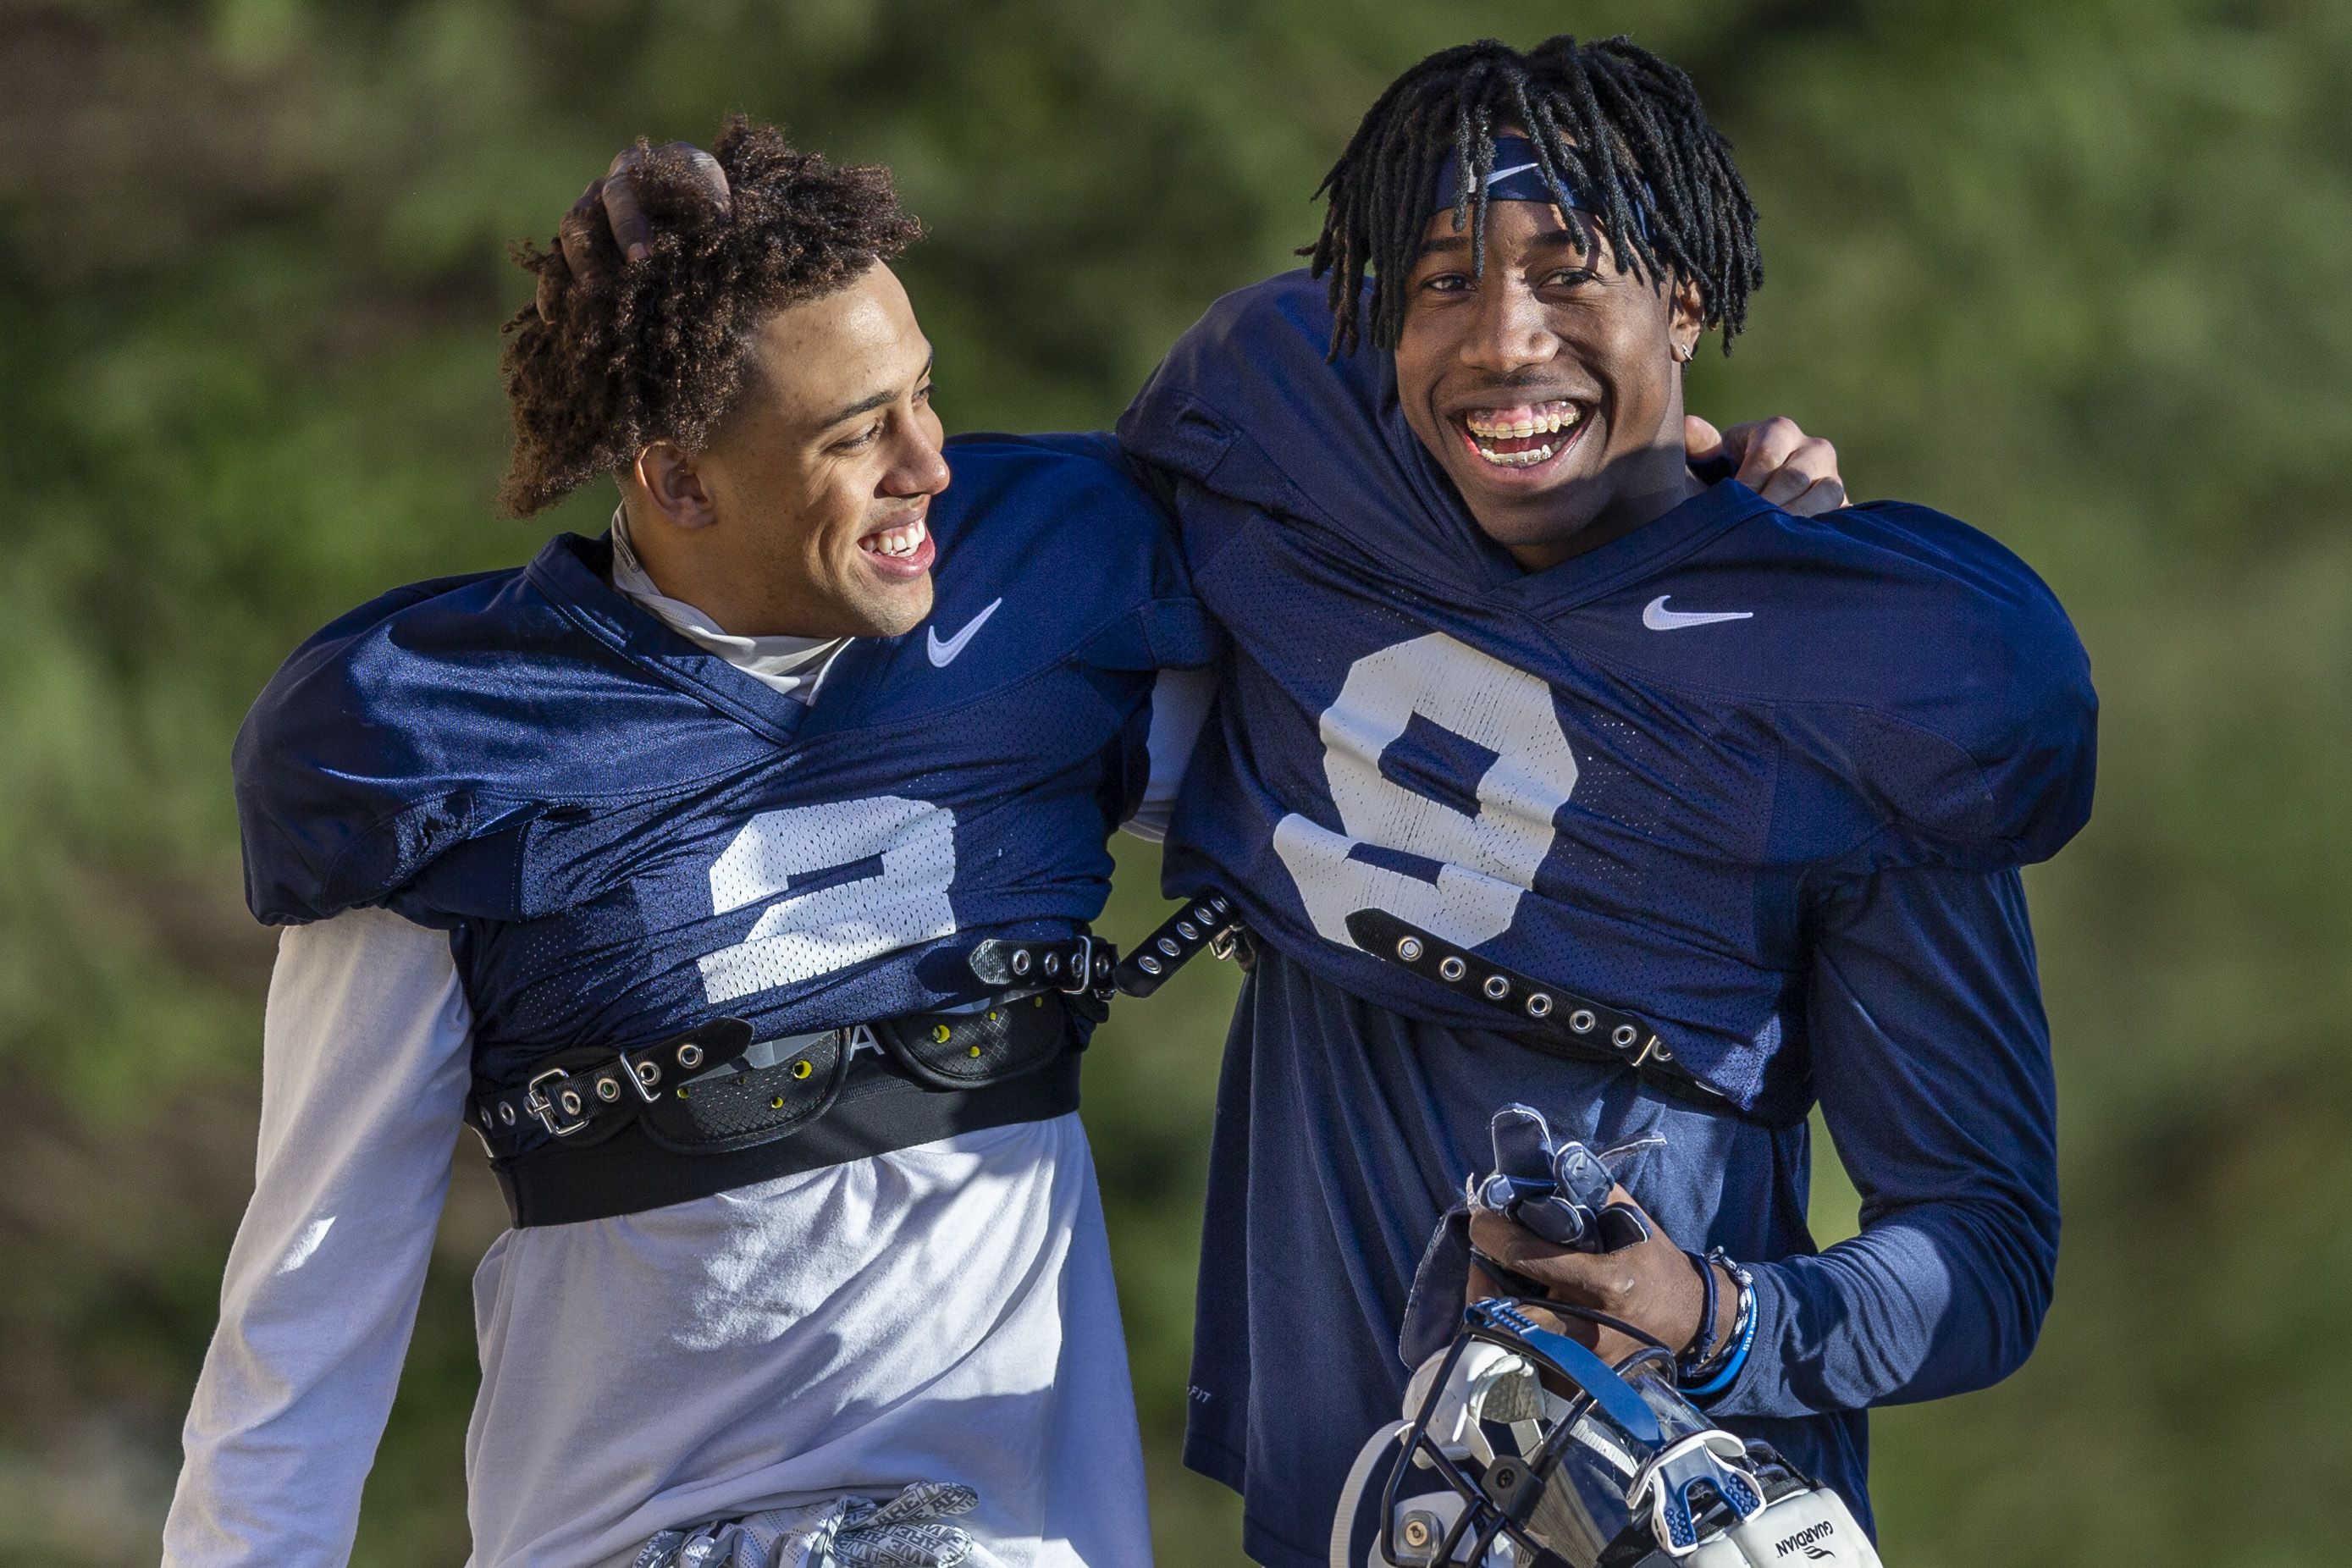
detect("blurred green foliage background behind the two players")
[0,0,2352,1568]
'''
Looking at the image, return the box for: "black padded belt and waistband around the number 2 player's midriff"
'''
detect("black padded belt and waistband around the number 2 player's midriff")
[466,982,1107,1227]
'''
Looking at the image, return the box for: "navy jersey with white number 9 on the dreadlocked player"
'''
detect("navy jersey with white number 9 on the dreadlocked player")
[1119,273,2095,1124]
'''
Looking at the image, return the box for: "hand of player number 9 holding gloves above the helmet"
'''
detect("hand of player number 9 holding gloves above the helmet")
[1470,1184,1708,1366]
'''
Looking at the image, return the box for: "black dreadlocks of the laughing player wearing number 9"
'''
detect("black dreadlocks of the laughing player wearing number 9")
[1298,33,1764,357]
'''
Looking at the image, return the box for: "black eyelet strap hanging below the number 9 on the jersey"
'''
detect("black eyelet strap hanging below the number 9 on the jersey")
[1348,910,1724,1100]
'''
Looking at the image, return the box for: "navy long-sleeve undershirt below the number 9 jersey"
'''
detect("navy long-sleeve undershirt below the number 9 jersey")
[1185,868,2058,1565]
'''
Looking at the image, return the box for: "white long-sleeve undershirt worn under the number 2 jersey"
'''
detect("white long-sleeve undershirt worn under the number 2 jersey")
[152,549,1171,1568]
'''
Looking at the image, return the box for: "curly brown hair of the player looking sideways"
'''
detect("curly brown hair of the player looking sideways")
[499,115,922,517]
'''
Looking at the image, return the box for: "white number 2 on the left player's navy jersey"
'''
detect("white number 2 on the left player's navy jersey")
[701,794,955,1004]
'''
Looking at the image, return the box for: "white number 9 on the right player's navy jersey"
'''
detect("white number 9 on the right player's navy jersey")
[1275,632,1576,947]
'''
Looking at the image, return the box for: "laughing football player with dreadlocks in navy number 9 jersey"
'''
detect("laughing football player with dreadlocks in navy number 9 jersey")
[1119,37,2095,1568]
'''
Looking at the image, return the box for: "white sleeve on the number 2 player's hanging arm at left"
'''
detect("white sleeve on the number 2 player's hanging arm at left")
[163,910,472,1568]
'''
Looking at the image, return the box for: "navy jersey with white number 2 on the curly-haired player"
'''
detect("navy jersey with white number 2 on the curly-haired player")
[235,437,1213,1081]
